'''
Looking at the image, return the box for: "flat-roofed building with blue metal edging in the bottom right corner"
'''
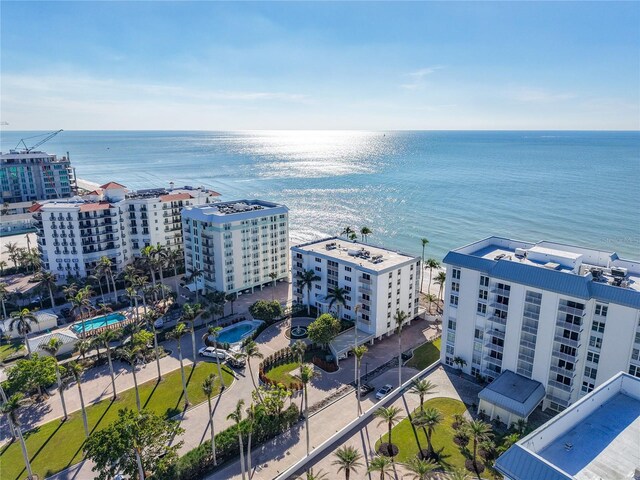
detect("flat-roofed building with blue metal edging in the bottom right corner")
[494,372,640,480]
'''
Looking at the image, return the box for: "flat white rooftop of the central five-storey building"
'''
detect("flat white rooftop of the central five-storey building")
[292,237,418,272]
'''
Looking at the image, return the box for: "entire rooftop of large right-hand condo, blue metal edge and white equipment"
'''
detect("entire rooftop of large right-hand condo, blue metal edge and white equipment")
[444,237,640,308]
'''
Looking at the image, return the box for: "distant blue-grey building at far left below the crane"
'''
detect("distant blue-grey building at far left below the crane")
[0,150,76,203]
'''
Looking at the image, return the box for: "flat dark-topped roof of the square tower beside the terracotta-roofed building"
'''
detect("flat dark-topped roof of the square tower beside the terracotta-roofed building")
[184,200,289,222]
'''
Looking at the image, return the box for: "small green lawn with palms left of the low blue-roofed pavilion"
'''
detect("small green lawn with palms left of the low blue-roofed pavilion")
[376,398,466,470]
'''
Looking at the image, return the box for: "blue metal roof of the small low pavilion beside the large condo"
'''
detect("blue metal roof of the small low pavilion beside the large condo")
[478,370,544,418]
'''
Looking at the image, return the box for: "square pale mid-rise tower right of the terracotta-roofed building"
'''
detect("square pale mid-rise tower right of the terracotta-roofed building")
[182,200,289,293]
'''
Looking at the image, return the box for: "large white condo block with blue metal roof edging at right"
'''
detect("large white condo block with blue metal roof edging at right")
[441,237,640,411]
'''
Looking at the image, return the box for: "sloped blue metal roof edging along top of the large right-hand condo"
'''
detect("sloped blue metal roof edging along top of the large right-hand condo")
[443,252,640,308]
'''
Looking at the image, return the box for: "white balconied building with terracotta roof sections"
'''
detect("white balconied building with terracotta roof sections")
[32,182,219,280]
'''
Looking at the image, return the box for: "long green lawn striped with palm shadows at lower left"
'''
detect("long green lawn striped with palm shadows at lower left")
[0,362,233,480]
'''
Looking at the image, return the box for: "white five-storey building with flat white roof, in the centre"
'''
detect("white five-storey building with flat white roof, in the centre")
[291,238,420,338]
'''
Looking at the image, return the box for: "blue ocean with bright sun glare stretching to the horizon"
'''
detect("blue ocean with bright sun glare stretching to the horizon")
[0,131,640,259]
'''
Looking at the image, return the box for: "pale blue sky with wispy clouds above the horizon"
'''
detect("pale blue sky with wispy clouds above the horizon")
[0,1,640,130]
